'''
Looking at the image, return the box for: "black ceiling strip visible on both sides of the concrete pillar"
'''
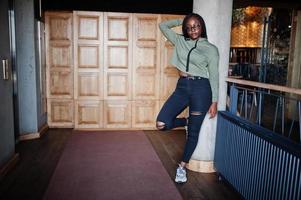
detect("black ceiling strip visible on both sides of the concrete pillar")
[41,0,301,14]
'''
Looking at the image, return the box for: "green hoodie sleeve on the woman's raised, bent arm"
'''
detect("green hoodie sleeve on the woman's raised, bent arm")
[159,19,183,45]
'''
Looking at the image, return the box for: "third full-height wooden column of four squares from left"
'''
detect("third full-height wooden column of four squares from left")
[104,13,133,128]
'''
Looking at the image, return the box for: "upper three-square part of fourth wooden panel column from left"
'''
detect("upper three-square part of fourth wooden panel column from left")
[132,14,160,100]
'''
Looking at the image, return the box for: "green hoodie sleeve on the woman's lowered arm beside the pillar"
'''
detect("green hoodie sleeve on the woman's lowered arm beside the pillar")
[208,48,219,102]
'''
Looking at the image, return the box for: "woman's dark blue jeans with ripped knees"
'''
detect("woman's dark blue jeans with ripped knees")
[157,77,212,163]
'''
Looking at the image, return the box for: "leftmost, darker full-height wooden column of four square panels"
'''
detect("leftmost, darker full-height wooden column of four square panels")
[45,12,74,127]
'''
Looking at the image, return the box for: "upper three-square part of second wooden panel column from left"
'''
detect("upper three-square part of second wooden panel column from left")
[73,11,103,100]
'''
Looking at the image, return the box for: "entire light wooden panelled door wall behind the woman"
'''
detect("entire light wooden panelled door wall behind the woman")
[45,11,184,129]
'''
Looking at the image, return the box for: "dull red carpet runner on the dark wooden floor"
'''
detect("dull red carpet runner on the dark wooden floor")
[44,131,182,200]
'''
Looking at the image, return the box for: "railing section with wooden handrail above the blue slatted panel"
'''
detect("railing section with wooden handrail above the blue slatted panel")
[226,77,301,143]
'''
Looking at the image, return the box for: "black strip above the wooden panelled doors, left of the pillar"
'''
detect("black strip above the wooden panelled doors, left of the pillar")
[42,0,193,14]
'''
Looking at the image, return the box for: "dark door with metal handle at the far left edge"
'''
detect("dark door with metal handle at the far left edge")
[0,0,15,168]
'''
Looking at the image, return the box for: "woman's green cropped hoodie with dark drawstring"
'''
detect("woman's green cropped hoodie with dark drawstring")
[159,19,219,102]
